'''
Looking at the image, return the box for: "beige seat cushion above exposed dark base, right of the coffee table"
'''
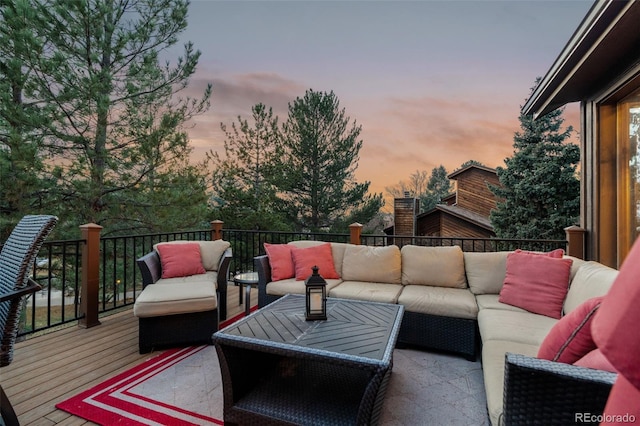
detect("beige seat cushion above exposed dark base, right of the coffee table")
[398,285,478,319]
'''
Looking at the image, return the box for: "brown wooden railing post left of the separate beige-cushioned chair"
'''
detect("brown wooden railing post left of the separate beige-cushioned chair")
[78,223,102,328]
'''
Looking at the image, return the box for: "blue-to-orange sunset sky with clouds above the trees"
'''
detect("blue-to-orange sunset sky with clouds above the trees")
[174,0,593,203]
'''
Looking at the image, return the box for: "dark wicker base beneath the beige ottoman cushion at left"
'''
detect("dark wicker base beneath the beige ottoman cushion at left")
[138,309,218,354]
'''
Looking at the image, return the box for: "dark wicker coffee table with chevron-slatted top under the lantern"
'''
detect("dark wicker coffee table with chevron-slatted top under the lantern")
[213,295,404,425]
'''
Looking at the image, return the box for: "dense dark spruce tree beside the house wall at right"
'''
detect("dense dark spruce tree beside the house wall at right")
[491,84,580,239]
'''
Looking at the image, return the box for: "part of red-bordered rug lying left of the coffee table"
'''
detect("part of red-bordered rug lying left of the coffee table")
[56,314,251,426]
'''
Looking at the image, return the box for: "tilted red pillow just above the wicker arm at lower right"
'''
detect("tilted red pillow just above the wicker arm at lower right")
[538,297,602,364]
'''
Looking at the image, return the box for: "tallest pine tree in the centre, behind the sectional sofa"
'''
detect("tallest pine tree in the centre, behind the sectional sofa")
[276,90,382,231]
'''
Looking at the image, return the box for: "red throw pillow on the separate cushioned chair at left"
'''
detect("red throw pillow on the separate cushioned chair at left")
[156,243,206,278]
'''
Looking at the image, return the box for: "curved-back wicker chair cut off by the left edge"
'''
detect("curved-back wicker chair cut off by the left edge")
[0,215,58,426]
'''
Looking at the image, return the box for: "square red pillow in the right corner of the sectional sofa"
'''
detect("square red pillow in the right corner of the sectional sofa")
[498,252,573,319]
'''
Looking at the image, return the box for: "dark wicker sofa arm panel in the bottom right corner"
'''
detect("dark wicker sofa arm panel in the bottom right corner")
[503,353,616,426]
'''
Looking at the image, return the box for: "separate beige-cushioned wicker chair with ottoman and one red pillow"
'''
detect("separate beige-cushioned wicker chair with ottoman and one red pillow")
[133,240,231,354]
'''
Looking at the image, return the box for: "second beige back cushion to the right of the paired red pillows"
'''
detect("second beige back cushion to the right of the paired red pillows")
[401,245,467,288]
